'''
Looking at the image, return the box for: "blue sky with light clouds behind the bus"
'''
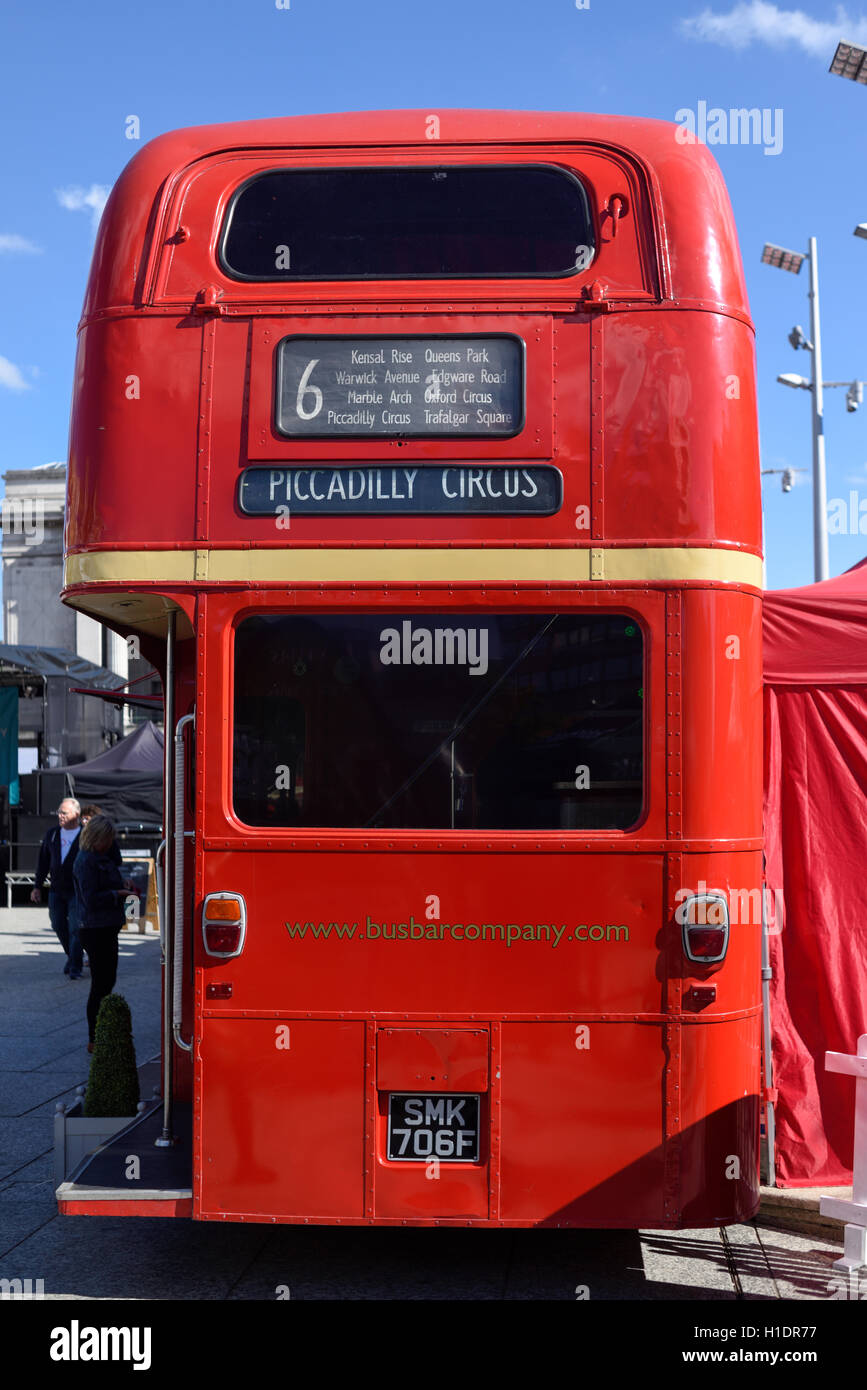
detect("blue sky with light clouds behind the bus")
[0,0,867,588]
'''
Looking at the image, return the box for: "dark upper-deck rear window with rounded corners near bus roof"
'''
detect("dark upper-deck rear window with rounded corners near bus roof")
[220,164,593,281]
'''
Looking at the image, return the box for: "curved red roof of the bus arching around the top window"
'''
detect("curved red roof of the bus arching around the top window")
[83,110,749,318]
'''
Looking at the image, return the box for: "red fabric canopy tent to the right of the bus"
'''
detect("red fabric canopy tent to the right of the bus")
[764,560,867,1187]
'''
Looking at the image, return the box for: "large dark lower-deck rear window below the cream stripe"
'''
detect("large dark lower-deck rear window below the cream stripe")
[233,613,643,830]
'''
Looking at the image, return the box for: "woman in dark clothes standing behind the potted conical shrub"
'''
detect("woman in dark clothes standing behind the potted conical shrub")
[72,816,128,1052]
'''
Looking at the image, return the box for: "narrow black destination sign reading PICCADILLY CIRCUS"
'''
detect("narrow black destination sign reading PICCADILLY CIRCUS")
[239,463,563,517]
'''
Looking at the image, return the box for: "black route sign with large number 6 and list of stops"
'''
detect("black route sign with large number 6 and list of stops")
[275,335,524,439]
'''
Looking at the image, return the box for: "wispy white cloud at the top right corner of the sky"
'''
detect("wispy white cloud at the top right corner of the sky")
[679,0,867,63]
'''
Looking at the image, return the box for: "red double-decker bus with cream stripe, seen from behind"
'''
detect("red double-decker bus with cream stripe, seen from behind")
[58,111,761,1227]
